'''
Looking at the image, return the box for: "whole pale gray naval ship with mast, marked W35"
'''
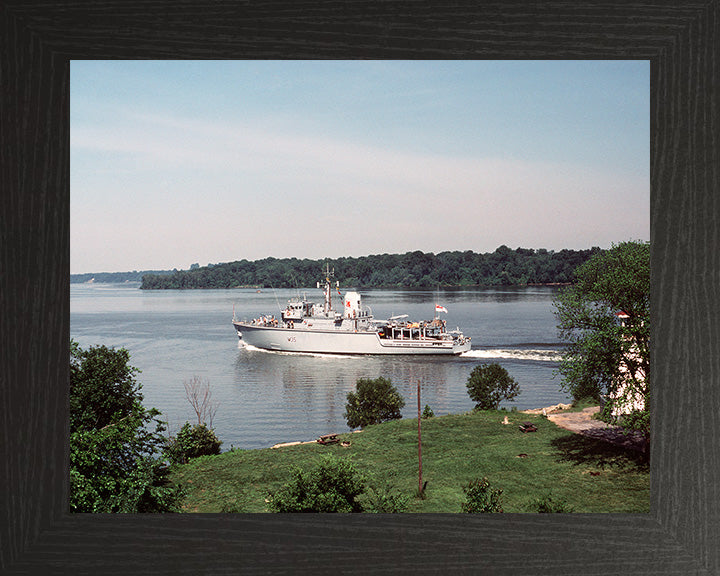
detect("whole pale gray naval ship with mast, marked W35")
[233,269,470,354]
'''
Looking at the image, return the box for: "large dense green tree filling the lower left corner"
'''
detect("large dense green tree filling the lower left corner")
[70,341,182,513]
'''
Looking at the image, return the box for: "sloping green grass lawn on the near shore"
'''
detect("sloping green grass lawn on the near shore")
[172,411,650,513]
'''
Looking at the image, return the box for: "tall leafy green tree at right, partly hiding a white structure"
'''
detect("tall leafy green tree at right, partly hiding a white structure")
[555,242,650,437]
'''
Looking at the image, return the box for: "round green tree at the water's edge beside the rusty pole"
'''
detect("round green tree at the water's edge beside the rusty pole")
[343,376,405,428]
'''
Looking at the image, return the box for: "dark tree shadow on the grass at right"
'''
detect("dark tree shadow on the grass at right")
[552,434,650,472]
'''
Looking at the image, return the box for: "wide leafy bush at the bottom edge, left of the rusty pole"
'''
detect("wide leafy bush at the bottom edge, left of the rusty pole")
[270,456,365,512]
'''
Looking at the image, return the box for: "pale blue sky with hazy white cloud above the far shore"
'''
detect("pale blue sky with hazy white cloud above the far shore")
[70,61,650,273]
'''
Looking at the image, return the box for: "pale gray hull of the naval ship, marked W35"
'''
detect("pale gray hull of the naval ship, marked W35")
[233,322,470,355]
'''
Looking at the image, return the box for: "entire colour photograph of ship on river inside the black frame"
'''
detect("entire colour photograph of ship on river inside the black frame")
[68,59,654,514]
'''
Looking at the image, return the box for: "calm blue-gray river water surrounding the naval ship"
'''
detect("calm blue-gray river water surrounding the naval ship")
[70,284,568,450]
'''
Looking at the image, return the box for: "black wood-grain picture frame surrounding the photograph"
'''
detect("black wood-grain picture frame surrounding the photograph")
[0,0,720,575]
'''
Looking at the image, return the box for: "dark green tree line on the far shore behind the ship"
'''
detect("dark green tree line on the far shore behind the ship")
[140,245,602,290]
